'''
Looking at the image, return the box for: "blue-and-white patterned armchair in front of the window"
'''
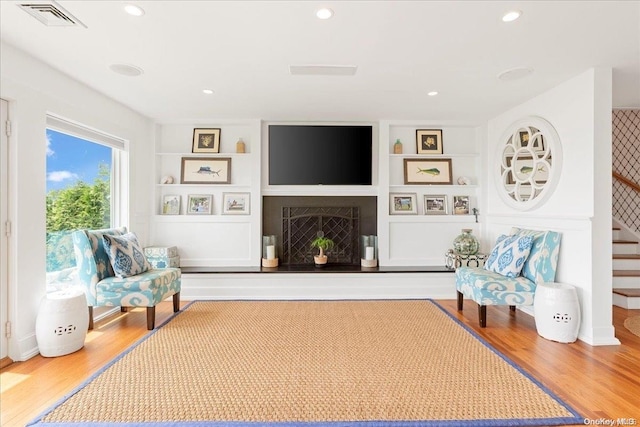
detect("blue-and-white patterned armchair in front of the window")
[73,227,181,330]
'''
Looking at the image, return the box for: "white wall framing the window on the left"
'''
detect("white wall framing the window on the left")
[0,43,154,360]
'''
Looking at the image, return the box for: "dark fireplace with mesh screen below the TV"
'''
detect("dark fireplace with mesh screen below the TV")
[262,196,377,265]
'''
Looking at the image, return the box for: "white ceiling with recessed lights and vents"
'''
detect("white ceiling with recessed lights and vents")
[0,0,640,123]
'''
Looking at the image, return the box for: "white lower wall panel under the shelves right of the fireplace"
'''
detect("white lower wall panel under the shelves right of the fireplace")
[389,222,478,266]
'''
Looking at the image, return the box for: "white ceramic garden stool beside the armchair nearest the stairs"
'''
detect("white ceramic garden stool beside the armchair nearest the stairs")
[533,283,580,343]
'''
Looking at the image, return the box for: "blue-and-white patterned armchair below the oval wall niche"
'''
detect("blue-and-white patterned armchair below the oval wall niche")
[456,228,561,328]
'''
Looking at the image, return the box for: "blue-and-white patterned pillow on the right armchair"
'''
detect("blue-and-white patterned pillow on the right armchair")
[484,234,533,277]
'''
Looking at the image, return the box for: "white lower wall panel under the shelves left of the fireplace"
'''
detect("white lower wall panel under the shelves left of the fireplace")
[153,220,255,267]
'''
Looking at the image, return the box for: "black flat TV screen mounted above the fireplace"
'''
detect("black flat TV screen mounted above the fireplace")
[269,125,373,185]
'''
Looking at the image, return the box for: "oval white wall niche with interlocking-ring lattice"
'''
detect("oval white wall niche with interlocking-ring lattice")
[494,117,562,211]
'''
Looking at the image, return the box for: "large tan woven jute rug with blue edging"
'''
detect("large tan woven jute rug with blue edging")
[32,300,584,426]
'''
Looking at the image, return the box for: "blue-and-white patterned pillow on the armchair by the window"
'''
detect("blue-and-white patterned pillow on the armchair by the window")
[102,233,151,278]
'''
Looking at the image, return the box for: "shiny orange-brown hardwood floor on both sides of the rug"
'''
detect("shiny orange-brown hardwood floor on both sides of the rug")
[0,300,640,426]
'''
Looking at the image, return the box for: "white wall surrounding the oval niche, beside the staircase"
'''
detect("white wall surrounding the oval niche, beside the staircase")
[484,69,619,345]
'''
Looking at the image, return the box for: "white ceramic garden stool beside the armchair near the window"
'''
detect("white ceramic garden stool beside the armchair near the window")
[36,288,89,357]
